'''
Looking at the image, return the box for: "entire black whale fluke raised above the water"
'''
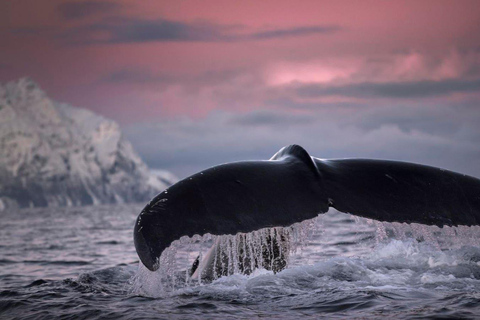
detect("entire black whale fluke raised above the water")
[134,145,480,271]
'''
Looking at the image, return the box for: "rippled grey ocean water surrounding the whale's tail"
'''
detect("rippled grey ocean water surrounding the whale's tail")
[0,205,480,319]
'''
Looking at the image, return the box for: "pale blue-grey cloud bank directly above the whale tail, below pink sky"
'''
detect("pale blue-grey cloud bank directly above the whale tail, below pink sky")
[125,101,480,177]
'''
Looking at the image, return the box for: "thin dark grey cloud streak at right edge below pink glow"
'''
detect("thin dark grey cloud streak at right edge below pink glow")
[297,79,480,98]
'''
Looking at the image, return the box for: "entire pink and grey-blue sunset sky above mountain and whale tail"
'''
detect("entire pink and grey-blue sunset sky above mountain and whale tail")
[0,0,480,178]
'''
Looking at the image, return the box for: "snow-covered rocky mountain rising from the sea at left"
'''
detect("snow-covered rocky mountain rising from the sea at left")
[0,78,175,211]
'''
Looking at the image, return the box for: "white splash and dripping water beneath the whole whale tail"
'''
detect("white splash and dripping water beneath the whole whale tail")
[131,211,480,297]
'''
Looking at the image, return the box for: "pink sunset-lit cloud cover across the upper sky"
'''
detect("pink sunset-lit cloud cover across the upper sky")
[0,0,480,121]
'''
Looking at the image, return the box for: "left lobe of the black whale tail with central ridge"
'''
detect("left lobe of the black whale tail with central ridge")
[134,146,328,271]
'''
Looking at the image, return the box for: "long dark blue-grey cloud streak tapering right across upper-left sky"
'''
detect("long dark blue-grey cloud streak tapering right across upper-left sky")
[57,16,340,44]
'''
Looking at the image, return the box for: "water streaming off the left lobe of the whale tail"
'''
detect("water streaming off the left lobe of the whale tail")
[130,219,318,296]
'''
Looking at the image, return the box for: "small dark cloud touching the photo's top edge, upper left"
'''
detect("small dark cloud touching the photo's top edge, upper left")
[57,1,121,20]
